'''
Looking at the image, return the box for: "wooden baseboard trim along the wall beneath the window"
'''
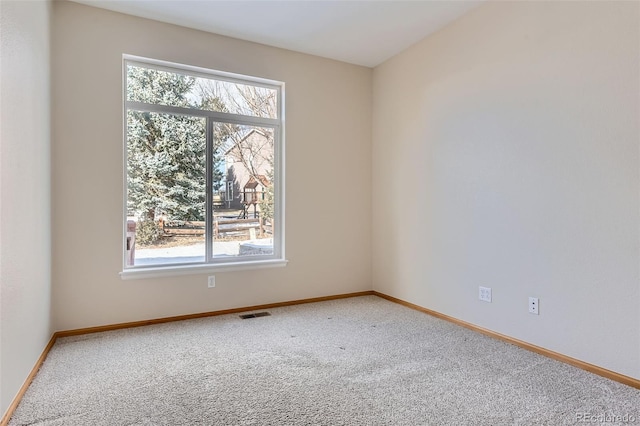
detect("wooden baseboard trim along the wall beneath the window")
[56,290,374,338]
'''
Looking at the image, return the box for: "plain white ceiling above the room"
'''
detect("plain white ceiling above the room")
[72,0,484,67]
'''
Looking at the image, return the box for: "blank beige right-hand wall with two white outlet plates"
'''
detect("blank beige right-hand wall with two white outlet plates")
[373,2,640,378]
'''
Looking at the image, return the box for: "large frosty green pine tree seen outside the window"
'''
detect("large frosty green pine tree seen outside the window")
[127,66,224,221]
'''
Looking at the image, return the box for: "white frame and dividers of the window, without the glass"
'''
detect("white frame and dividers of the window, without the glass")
[120,55,287,279]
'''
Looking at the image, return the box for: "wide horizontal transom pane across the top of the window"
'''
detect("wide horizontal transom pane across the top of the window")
[127,64,278,118]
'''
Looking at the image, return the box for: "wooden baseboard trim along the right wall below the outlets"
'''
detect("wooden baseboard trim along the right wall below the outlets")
[373,291,640,389]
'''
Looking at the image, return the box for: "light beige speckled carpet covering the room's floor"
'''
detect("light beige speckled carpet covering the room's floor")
[9,296,640,426]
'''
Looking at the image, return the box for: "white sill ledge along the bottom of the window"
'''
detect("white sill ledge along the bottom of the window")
[120,259,288,280]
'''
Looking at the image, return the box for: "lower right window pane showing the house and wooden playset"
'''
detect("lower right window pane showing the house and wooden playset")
[212,123,274,257]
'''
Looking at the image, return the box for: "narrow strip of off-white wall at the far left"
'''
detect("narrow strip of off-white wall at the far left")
[0,1,52,415]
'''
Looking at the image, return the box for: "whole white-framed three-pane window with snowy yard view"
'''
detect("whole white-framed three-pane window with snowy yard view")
[122,56,285,278]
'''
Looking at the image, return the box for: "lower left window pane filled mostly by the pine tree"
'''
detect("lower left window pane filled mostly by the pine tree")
[127,110,206,266]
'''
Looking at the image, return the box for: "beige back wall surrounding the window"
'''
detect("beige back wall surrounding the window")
[52,2,372,330]
